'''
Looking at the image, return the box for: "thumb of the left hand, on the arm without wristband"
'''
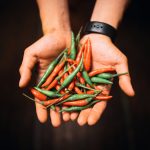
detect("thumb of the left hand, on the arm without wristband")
[19,48,37,88]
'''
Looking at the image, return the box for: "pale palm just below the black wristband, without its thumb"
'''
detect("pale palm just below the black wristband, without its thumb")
[87,35,124,70]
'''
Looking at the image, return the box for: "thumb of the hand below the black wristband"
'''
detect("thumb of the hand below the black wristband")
[116,61,135,96]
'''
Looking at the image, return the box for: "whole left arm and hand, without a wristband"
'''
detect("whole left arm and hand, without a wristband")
[19,0,71,126]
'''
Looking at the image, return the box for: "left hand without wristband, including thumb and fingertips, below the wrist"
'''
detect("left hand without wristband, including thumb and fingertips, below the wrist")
[19,30,71,127]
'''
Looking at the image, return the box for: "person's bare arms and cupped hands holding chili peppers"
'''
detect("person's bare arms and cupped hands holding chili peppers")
[19,0,134,127]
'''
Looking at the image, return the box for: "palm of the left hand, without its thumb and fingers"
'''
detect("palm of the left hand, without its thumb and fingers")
[33,35,67,77]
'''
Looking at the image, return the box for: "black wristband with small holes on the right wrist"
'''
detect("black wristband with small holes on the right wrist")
[83,21,117,41]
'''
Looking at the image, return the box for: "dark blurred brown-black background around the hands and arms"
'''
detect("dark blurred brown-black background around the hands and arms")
[0,0,150,150]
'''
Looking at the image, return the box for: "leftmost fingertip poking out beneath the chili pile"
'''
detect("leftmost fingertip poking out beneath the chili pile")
[35,99,47,123]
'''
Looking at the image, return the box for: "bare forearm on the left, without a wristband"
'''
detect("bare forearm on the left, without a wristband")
[37,0,70,34]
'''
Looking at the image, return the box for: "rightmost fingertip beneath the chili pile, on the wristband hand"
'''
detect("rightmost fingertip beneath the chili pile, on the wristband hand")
[88,101,106,125]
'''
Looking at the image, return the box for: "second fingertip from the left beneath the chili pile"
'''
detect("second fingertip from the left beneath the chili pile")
[50,107,61,127]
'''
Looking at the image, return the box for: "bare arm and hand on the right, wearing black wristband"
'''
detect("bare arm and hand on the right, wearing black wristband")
[74,0,134,125]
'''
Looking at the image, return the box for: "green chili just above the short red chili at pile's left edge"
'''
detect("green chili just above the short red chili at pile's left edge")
[34,87,62,97]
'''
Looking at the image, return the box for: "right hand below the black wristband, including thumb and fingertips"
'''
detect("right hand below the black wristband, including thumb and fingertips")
[71,34,134,125]
